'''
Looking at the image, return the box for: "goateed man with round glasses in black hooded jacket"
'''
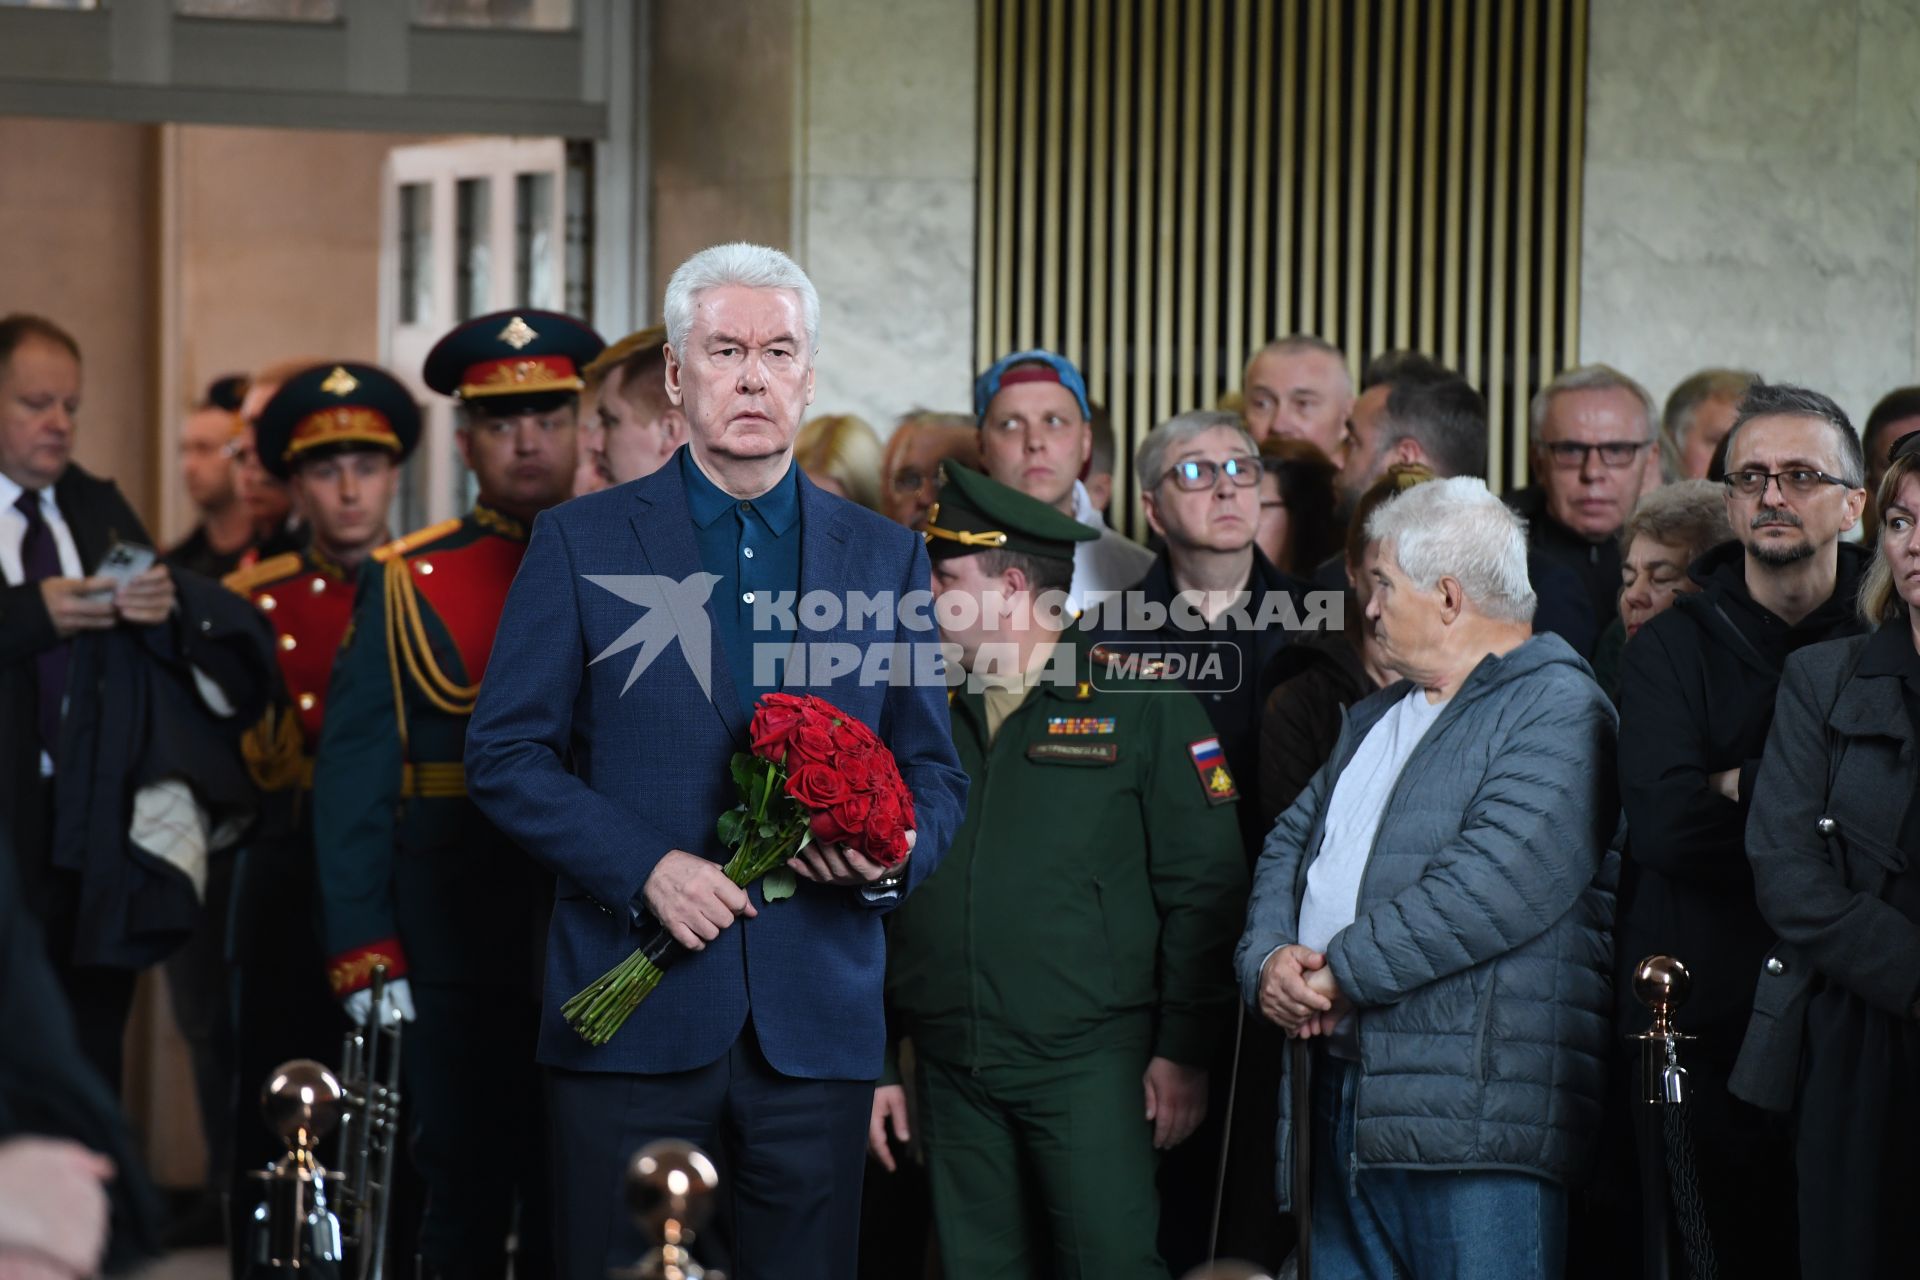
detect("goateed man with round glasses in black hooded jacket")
[1615,384,1870,1276]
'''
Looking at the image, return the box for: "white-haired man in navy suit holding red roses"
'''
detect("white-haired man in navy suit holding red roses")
[467,244,966,1280]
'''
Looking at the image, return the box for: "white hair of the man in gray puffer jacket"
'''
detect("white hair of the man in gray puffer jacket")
[1367,476,1536,622]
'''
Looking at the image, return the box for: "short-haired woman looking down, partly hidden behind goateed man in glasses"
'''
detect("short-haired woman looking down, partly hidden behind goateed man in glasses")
[1594,480,1734,700]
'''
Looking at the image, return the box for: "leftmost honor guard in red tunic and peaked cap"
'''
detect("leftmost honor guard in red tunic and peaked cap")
[225,363,420,1242]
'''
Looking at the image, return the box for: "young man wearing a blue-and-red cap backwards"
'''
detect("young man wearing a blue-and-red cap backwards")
[973,347,1152,610]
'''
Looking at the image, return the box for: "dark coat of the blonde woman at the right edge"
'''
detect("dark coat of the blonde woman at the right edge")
[1734,624,1920,1109]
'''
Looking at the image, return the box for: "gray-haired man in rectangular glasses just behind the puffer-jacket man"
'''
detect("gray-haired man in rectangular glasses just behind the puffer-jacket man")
[1507,365,1659,656]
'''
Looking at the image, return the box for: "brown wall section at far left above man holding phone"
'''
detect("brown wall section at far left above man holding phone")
[0,117,159,521]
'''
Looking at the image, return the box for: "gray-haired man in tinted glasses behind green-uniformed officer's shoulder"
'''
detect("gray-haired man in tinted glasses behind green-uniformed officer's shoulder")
[1121,413,1308,1274]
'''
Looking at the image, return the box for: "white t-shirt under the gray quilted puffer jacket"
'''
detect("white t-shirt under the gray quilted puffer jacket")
[1300,687,1446,1057]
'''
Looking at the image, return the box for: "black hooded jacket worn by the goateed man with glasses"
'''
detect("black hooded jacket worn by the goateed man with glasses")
[1617,541,1868,1051]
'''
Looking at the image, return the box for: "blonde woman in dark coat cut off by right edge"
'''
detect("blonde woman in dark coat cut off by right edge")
[1730,432,1920,1280]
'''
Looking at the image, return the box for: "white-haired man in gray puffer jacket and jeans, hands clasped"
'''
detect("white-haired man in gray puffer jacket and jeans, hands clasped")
[1235,478,1619,1280]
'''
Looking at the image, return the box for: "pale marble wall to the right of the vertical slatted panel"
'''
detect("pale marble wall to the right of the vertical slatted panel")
[1580,0,1920,429]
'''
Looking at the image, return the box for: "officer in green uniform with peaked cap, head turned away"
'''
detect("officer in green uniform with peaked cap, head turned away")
[874,462,1246,1280]
